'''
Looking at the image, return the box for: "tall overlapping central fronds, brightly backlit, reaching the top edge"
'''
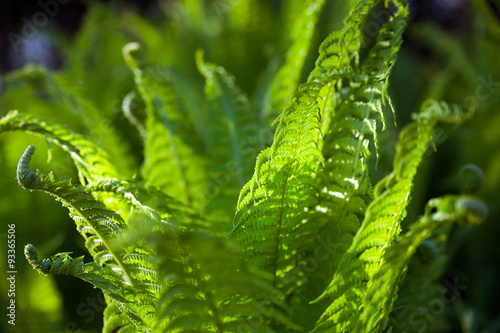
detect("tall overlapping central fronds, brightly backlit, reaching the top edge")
[232,1,408,296]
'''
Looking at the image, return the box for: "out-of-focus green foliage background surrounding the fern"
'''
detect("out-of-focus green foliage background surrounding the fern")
[0,0,500,333]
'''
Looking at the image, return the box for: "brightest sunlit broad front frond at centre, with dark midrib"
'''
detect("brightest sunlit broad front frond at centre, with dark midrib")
[231,75,322,283]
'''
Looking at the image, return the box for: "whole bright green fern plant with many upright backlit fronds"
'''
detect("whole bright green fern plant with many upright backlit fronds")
[0,0,487,333]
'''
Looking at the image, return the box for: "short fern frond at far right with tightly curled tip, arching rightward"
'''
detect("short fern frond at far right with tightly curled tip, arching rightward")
[353,196,487,333]
